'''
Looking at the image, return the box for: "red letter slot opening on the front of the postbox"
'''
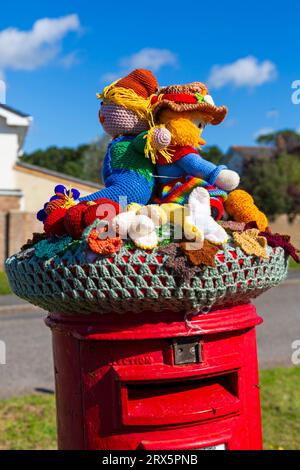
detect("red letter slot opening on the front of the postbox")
[121,373,240,426]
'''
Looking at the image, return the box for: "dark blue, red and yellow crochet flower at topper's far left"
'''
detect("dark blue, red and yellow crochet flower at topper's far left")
[37,184,80,222]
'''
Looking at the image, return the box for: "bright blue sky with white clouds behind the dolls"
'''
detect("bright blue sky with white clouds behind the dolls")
[0,0,300,151]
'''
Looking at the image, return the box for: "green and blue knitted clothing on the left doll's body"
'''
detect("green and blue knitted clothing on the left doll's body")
[80,132,154,206]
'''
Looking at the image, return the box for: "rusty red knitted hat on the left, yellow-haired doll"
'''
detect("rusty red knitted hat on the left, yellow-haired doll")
[115,69,158,99]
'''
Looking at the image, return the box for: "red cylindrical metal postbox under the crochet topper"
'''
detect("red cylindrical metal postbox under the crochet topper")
[46,304,262,450]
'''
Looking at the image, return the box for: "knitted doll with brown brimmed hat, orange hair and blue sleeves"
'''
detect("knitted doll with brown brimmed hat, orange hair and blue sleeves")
[151,82,240,218]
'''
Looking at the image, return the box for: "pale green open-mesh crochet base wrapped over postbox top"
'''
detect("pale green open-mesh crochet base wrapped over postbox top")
[6,245,288,314]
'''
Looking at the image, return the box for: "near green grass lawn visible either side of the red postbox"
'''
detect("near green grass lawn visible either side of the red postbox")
[0,367,300,450]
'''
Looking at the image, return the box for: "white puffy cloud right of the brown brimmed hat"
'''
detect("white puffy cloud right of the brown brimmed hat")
[208,56,277,88]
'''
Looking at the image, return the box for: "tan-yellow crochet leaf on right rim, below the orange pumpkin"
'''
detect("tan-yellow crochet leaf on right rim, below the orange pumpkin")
[233,228,268,258]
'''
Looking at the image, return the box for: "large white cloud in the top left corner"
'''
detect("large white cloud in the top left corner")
[0,14,80,73]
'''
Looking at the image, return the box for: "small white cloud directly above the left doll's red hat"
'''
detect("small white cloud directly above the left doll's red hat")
[101,47,178,82]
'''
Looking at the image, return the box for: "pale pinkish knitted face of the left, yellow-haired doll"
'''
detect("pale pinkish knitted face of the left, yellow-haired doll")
[99,101,149,137]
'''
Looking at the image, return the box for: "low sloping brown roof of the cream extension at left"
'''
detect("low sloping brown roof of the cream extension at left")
[15,160,101,191]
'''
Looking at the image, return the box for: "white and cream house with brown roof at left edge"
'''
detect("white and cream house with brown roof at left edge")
[0,96,99,271]
